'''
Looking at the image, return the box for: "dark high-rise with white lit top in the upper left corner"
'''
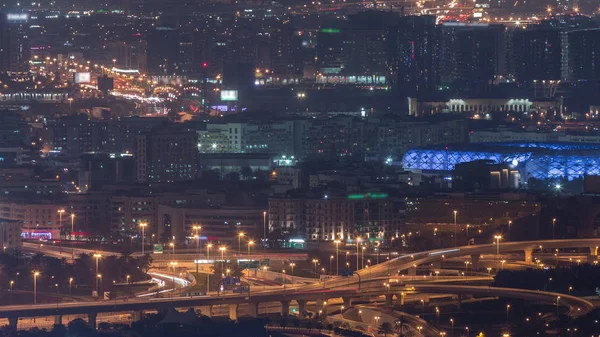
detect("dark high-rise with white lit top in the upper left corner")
[0,13,31,72]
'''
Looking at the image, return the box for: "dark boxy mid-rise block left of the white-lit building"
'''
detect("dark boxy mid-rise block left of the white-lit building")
[135,126,198,183]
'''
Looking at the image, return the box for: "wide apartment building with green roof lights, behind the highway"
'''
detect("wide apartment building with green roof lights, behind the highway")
[267,192,404,242]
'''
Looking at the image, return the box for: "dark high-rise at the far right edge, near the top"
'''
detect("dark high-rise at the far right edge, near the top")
[561,28,600,81]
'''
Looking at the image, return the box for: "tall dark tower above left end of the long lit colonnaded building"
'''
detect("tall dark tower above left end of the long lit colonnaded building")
[387,15,439,95]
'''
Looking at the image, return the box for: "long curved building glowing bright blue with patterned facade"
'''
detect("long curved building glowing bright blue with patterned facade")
[403,142,600,181]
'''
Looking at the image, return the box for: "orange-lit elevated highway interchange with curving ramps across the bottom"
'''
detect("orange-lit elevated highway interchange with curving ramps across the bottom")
[5,239,600,334]
